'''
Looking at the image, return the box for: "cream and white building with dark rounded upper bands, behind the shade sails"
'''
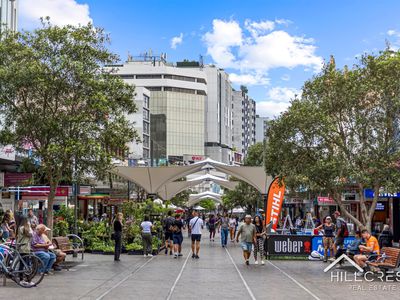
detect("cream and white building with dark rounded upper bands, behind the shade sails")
[109,55,207,164]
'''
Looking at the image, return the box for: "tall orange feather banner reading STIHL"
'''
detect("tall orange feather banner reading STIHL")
[265,178,285,230]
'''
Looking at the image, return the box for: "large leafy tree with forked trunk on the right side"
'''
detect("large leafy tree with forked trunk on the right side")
[265,49,400,229]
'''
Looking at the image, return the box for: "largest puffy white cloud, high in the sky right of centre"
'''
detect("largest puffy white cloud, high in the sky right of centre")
[203,19,323,84]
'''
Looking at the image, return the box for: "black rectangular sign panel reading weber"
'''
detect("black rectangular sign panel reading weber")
[268,235,312,255]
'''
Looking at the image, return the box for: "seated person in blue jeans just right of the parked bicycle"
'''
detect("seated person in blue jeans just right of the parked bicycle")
[31,224,56,275]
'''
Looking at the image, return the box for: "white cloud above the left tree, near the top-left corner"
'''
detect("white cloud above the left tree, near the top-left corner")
[19,0,92,29]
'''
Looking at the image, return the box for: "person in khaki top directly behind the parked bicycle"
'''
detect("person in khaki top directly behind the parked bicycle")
[17,216,34,287]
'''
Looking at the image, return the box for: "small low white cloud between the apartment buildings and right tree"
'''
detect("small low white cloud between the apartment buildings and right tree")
[256,87,301,118]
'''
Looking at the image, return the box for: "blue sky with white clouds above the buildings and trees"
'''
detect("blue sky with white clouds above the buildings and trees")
[19,0,400,116]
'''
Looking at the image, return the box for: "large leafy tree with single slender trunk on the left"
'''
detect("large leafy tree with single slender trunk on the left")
[0,22,137,228]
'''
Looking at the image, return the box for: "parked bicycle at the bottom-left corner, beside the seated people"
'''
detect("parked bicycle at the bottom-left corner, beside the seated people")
[0,244,44,288]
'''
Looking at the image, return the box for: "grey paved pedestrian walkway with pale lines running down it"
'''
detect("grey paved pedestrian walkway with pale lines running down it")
[0,231,400,300]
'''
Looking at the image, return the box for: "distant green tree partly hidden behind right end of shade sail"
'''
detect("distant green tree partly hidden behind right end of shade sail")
[222,143,264,213]
